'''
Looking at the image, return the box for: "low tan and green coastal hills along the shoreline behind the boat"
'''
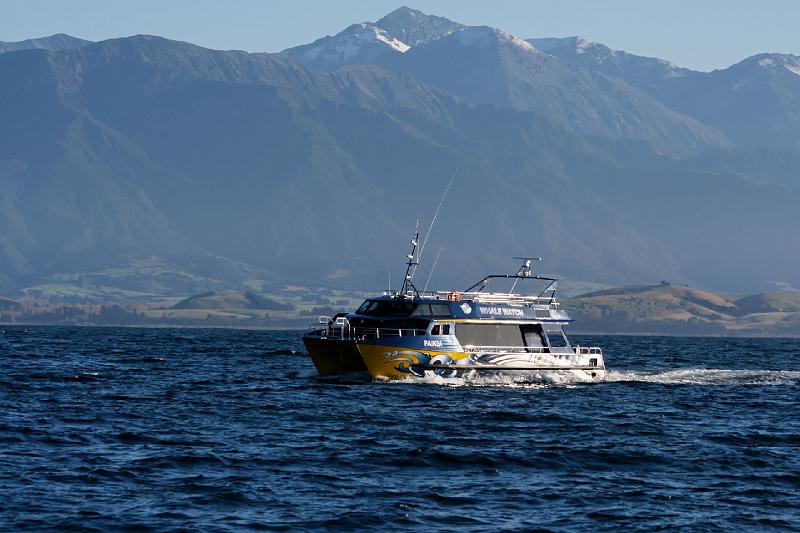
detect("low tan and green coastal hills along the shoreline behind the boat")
[0,282,800,339]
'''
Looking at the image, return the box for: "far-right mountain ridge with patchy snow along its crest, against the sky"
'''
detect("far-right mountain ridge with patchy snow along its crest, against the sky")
[528,37,800,148]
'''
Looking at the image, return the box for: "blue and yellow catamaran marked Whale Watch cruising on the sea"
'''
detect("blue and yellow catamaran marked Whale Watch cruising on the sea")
[303,229,605,381]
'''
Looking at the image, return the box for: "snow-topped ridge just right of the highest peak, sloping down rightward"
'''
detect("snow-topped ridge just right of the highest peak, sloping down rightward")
[376,26,728,154]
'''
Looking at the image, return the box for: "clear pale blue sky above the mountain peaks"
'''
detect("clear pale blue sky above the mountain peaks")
[0,0,800,70]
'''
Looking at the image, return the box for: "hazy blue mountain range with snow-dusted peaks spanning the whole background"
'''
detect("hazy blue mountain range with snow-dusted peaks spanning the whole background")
[0,8,800,298]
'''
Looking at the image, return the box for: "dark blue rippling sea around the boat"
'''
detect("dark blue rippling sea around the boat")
[0,327,800,532]
